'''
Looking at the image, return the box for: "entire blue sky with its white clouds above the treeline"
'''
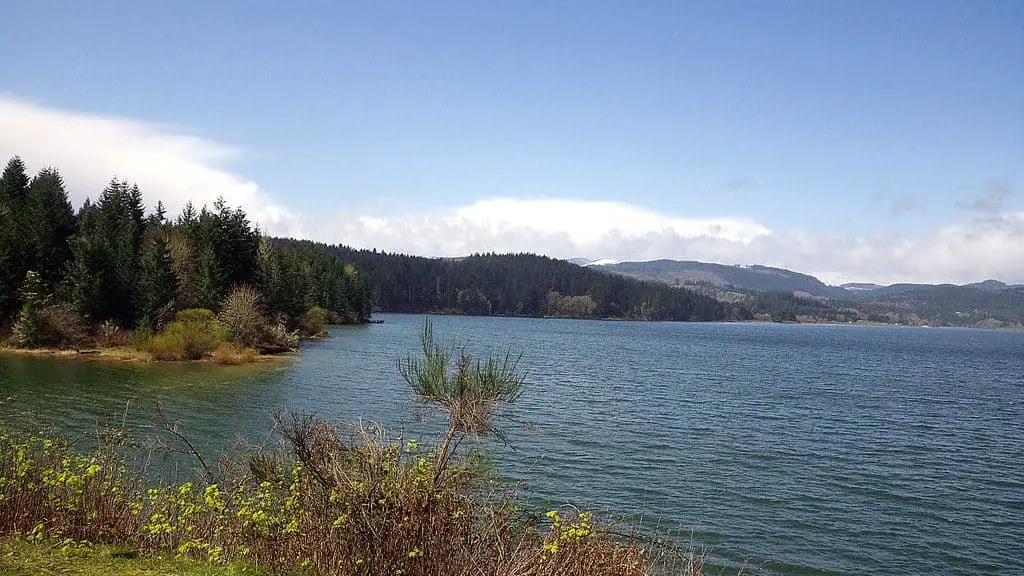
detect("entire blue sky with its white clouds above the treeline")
[0,0,1024,284]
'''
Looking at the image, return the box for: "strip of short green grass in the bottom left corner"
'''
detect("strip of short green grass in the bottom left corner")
[0,540,269,576]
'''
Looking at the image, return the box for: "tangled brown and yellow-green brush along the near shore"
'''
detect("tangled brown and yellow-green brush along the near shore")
[0,417,720,576]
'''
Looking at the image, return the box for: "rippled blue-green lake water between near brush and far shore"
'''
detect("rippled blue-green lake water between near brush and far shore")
[0,315,1024,575]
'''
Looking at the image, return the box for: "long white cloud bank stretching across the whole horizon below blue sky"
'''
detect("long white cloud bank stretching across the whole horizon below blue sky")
[0,98,1024,283]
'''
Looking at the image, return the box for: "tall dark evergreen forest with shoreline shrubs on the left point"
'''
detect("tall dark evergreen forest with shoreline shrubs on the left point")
[0,157,371,354]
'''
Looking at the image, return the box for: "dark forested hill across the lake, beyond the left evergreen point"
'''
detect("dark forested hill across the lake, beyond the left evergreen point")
[274,239,744,321]
